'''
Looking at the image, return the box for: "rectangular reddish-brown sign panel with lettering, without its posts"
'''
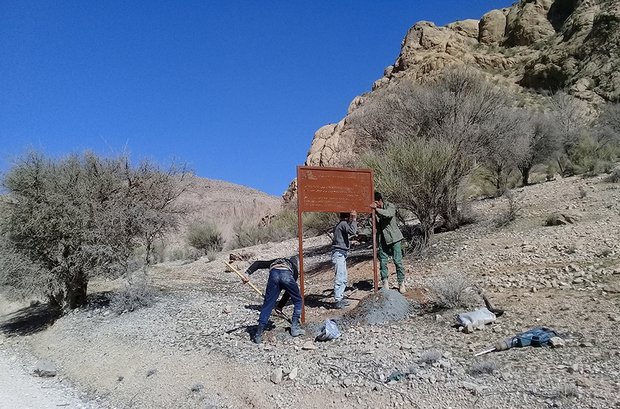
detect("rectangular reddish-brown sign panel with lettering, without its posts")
[297,166,374,213]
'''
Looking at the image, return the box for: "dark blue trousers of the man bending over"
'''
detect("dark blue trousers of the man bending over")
[258,268,301,328]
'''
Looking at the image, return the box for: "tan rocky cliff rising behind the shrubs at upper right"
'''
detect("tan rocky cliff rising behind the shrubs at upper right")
[302,0,620,174]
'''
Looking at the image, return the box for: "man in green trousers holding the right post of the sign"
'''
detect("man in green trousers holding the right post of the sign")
[370,192,405,293]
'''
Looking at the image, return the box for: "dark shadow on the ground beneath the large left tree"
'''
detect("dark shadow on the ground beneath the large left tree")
[0,304,62,336]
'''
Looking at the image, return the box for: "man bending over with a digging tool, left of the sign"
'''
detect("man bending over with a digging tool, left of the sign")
[244,256,305,344]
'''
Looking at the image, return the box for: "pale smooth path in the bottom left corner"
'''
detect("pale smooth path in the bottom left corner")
[0,349,99,409]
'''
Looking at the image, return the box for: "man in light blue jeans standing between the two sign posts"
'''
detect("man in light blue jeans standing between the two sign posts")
[332,210,357,309]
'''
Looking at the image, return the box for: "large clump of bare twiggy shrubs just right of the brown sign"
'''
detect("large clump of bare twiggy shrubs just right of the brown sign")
[356,70,549,244]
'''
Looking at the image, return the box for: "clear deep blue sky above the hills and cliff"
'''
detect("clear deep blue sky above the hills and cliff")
[0,0,512,195]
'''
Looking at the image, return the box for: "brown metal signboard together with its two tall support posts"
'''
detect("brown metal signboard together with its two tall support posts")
[297,166,379,322]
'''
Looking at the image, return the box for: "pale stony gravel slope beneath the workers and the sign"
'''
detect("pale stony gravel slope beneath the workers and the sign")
[5,174,620,408]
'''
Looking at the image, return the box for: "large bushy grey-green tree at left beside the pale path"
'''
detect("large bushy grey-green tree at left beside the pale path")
[0,153,189,308]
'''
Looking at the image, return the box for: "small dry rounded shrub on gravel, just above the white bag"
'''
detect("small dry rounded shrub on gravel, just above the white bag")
[428,272,479,309]
